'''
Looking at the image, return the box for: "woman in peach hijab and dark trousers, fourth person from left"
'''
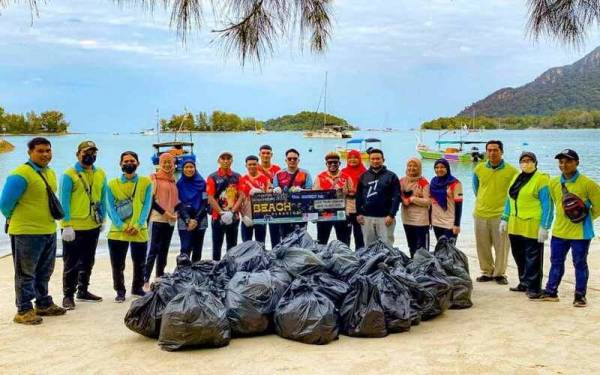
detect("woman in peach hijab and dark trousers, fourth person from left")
[144,152,179,290]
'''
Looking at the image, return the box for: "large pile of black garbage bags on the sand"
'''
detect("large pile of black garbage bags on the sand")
[125,230,473,351]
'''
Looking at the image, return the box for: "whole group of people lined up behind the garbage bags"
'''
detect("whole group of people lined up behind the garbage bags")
[0,137,600,324]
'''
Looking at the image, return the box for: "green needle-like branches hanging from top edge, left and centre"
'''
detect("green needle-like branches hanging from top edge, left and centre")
[0,0,332,64]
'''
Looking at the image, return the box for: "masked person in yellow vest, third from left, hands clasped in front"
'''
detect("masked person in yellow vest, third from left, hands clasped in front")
[106,151,152,302]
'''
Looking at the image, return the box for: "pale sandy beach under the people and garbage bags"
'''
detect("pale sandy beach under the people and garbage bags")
[0,240,600,374]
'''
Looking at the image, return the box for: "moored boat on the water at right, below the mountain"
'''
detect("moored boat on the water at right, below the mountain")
[417,140,486,163]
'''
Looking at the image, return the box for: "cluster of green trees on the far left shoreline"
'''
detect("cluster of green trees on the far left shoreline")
[0,107,69,134]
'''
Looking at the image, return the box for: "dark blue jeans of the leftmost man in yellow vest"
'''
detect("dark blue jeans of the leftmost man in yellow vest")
[11,234,56,313]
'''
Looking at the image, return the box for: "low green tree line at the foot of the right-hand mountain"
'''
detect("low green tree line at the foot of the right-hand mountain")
[421,109,600,130]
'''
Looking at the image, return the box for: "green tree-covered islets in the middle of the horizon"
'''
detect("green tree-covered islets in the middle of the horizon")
[159,111,354,132]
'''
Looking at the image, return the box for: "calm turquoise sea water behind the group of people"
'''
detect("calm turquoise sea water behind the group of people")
[0,130,600,253]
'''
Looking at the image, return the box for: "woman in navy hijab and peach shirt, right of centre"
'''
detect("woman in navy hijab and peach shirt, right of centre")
[429,159,463,240]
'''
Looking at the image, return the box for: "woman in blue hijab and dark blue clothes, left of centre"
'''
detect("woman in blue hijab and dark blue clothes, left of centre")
[176,160,208,262]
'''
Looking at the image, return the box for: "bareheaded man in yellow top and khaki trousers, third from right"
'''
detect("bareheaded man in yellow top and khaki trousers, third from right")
[473,140,518,285]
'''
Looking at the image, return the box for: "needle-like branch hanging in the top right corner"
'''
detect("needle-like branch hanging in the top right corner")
[527,0,600,45]
